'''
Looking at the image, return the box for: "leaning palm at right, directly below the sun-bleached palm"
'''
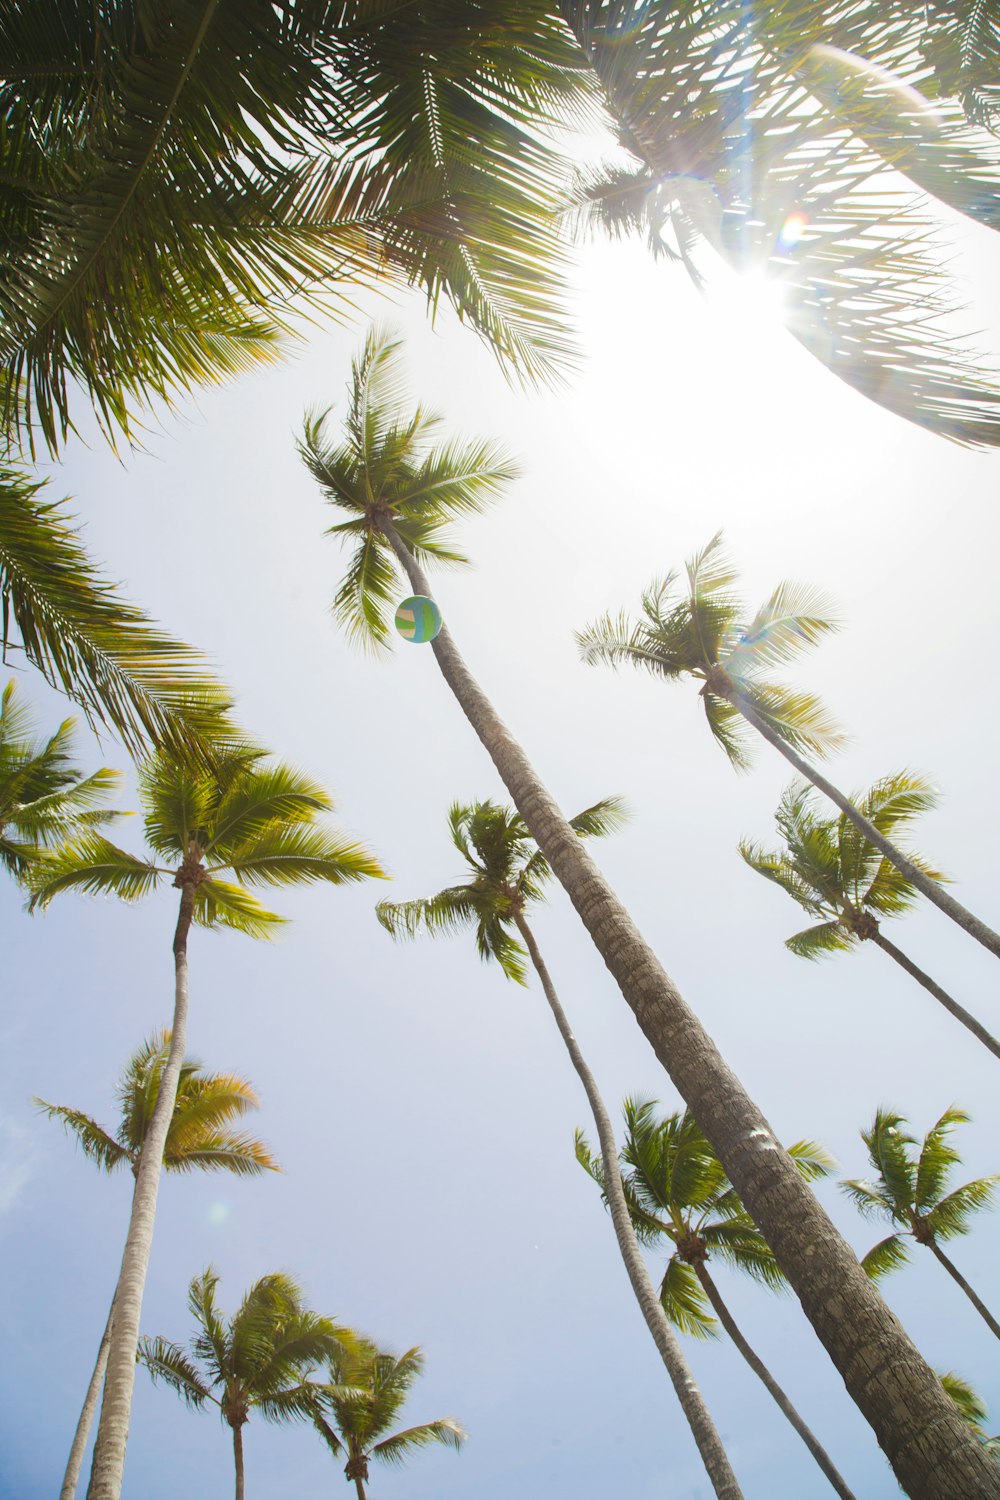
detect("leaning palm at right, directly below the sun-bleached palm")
[739,771,1000,1058]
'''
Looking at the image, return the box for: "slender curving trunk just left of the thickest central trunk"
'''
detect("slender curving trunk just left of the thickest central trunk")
[514,912,743,1500]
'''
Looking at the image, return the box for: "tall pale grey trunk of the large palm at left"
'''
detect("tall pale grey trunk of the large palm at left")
[87,884,195,1500]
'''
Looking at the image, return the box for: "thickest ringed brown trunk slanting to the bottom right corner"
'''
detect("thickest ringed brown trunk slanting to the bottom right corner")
[384,524,1000,1500]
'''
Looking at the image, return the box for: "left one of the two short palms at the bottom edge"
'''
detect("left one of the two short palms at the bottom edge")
[138,1266,354,1500]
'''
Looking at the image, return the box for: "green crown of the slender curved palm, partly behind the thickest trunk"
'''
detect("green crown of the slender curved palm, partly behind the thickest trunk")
[376,797,627,984]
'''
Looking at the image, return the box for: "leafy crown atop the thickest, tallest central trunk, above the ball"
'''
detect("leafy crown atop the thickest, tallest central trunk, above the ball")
[298,330,516,650]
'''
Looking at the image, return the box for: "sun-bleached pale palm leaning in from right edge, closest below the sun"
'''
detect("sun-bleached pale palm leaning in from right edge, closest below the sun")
[577,533,1000,959]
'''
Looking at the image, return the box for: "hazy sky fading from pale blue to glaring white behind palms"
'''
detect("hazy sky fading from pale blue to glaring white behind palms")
[0,202,1000,1500]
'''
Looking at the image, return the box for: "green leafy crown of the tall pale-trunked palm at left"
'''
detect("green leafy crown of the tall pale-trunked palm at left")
[31,747,382,938]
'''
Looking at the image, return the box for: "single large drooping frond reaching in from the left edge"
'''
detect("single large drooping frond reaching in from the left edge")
[0,468,229,758]
